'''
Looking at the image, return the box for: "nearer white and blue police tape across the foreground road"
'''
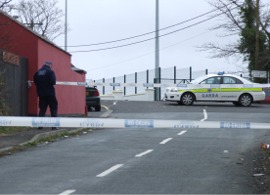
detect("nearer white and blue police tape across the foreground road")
[0,116,270,129]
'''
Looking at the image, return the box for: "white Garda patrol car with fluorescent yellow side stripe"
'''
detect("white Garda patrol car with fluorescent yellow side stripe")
[164,73,265,106]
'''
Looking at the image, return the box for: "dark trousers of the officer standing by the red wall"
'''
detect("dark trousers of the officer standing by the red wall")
[39,95,58,117]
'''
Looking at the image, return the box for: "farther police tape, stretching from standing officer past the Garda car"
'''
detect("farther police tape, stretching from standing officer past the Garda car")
[28,81,270,88]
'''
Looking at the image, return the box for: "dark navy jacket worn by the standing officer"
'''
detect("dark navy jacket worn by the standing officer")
[34,65,56,97]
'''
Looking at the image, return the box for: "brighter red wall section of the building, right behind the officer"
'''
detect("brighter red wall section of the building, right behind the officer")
[34,40,85,115]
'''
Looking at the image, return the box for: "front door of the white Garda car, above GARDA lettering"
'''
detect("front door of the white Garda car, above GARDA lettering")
[196,76,221,101]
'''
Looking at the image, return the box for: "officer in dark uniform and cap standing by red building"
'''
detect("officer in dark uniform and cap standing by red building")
[34,62,58,129]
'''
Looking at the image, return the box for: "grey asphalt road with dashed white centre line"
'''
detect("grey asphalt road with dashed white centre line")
[0,101,270,194]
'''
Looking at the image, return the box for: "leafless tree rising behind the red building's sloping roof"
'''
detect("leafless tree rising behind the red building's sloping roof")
[14,0,64,41]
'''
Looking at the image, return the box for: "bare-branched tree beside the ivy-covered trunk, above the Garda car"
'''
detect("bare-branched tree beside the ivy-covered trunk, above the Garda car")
[200,0,270,68]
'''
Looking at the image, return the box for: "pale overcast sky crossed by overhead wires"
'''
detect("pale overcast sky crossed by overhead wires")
[56,0,249,79]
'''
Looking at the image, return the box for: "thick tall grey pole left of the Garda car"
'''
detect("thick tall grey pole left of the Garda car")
[154,0,160,101]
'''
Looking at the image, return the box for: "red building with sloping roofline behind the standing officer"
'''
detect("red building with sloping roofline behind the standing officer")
[0,11,86,115]
